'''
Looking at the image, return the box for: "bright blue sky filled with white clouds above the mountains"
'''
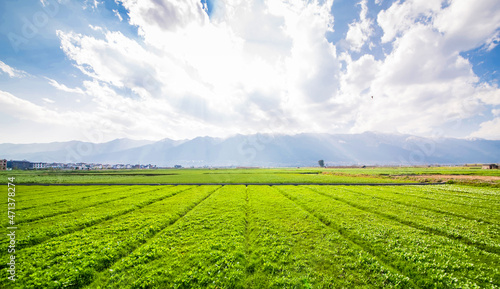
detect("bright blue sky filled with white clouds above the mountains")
[0,0,500,143]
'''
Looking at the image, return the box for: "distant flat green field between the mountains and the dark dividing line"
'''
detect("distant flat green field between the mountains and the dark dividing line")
[0,167,500,187]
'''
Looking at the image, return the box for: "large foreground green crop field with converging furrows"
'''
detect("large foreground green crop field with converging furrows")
[0,178,500,288]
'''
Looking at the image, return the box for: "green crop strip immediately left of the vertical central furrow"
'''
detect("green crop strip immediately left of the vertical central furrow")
[89,186,246,288]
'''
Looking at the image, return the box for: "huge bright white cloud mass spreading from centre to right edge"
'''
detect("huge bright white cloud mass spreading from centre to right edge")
[17,0,500,139]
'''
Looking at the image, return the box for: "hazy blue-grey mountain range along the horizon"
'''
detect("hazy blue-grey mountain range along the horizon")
[0,132,500,167]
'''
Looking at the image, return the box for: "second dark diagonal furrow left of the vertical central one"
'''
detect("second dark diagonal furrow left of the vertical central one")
[3,188,193,251]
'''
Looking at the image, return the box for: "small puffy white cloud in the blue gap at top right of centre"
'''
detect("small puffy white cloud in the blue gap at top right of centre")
[346,0,373,52]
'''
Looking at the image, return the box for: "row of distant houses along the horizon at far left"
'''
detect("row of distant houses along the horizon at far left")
[0,159,157,170]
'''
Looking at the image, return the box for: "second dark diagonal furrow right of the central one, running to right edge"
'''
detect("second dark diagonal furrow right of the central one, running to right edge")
[308,187,500,255]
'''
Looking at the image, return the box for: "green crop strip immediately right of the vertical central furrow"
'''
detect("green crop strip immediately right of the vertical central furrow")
[245,186,411,288]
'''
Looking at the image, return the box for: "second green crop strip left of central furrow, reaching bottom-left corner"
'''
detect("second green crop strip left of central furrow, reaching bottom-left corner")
[0,186,217,288]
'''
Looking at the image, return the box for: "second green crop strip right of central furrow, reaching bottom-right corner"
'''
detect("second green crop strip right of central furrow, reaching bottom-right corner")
[280,187,500,288]
